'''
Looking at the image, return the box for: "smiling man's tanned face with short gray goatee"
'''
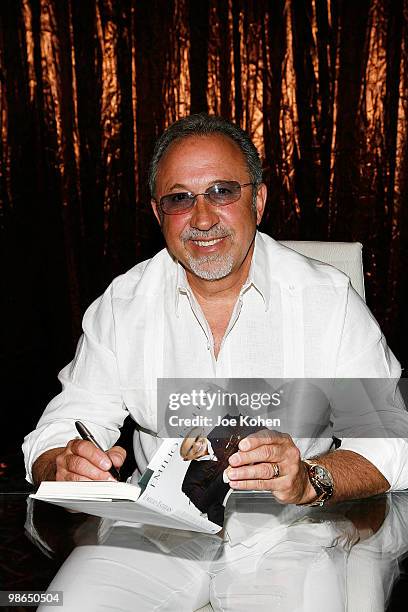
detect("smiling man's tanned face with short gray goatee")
[152,134,266,281]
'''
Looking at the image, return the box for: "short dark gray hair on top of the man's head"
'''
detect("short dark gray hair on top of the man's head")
[149,113,262,201]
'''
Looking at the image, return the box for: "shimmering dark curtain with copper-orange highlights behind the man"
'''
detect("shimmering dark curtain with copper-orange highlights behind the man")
[0,0,408,382]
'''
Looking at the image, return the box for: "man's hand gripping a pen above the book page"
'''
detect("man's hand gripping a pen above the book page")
[32,438,126,484]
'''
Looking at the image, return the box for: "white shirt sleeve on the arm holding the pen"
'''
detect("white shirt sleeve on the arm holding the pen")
[23,289,126,482]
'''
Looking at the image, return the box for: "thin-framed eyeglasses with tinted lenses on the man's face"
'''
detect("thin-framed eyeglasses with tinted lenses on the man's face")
[158,181,256,215]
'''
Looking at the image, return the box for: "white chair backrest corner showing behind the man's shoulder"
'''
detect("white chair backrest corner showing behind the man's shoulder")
[279,240,365,300]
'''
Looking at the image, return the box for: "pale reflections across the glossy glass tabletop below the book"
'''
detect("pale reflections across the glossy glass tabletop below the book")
[2,493,398,612]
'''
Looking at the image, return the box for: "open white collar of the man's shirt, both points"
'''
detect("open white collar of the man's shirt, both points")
[175,232,271,315]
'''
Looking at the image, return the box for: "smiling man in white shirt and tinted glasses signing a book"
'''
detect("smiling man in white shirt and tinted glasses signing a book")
[24,115,408,610]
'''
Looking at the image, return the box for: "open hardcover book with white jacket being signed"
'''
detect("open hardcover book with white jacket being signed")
[31,438,228,533]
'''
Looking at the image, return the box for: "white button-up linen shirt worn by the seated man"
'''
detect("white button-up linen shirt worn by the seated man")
[23,232,408,489]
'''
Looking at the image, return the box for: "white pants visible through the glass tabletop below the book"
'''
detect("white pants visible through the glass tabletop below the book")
[38,523,350,612]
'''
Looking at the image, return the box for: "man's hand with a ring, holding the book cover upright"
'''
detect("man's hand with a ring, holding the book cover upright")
[227,429,316,504]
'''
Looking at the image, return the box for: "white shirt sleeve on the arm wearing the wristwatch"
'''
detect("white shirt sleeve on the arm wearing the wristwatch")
[336,286,408,491]
